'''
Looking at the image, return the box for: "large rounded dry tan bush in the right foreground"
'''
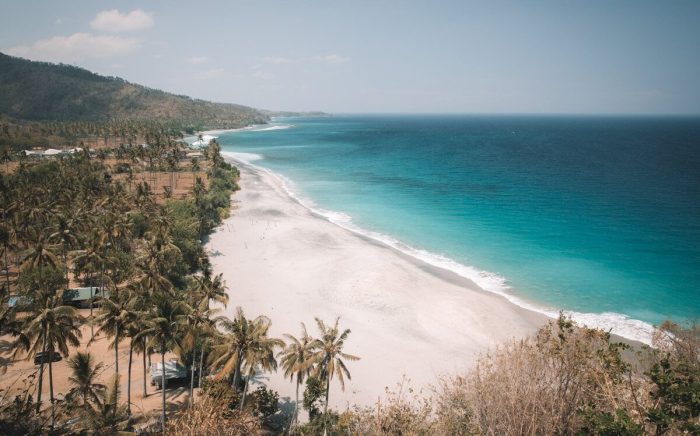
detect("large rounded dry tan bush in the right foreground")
[465,317,643,434]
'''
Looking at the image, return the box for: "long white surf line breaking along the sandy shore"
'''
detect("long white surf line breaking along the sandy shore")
[222,152,655,345]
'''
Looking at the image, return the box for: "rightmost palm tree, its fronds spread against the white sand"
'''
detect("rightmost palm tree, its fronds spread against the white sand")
[313,317,360,414]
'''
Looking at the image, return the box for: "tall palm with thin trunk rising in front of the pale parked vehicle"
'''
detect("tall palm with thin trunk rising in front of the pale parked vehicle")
[136,295,191,432]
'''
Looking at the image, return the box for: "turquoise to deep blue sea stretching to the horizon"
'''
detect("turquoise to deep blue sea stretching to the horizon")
[219,115,700,339]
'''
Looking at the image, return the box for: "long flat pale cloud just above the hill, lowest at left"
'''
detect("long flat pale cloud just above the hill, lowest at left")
[6,33,141,63]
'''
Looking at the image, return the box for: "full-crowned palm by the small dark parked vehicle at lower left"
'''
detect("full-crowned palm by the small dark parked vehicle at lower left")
[17,294,82,427]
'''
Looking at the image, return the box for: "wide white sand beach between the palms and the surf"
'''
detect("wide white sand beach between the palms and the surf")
[207,158,546,410]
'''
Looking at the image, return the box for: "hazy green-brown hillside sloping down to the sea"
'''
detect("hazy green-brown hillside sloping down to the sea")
[0,53,268,128]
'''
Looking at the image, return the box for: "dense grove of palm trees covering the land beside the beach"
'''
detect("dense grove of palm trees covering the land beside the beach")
[0,123,366,434]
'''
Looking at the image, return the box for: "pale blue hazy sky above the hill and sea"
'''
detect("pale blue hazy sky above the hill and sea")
[0,0,700,114]
